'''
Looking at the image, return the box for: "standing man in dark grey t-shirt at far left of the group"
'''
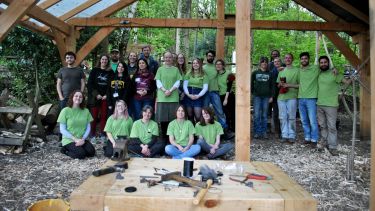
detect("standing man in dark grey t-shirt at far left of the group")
[56,51,85,110]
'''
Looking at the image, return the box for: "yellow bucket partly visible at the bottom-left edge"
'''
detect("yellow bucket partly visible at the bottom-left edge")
[27,199,70,211]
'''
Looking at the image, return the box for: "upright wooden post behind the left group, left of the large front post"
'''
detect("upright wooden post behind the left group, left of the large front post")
[216,0,225,59]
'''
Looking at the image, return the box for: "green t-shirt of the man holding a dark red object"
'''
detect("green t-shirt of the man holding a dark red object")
[276,67,299,100]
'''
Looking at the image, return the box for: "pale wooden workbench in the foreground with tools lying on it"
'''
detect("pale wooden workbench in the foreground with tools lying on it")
[70,158,316,211]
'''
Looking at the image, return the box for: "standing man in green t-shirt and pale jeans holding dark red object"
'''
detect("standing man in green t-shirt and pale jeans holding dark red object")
[276,53,299,144]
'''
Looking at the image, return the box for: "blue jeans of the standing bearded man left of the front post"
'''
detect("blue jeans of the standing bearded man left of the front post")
[203,91,228,129]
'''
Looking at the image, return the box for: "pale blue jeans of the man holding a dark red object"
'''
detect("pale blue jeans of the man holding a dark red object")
[277,99,297,139]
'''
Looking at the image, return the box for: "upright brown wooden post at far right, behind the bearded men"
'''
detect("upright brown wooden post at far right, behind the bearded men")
[359,33,372,140]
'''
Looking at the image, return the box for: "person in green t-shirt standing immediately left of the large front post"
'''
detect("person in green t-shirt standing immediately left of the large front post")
[215,59,236,131]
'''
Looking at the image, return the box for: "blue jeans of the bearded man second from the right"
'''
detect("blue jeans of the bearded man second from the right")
[298,98,319,142]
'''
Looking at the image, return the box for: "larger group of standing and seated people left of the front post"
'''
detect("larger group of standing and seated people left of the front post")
[56,46,235,159]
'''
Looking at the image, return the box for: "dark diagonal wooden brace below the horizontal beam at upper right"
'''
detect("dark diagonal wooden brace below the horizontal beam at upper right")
[323,31,361,67]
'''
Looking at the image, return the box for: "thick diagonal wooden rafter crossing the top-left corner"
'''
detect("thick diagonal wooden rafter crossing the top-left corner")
[0,0,37,42]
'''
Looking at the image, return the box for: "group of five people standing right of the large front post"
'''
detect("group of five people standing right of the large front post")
[251,50,351,155]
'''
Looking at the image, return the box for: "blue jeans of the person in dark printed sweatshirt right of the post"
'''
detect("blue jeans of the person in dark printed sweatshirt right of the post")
[253,96,270,135]
